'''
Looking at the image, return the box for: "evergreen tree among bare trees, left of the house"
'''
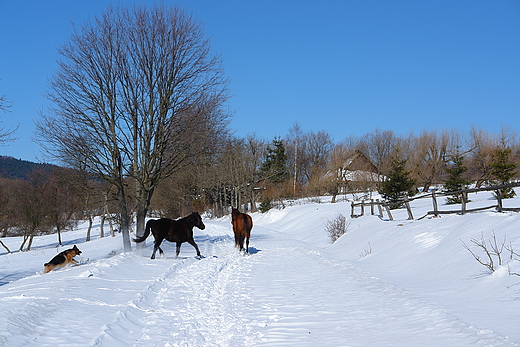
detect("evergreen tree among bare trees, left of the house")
[260,137,289,183]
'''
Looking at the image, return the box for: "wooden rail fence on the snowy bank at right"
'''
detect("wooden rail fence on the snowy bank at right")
[350,182,520,220]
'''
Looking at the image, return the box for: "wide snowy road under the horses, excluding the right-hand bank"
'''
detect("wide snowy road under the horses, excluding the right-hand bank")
[0,208,518,346]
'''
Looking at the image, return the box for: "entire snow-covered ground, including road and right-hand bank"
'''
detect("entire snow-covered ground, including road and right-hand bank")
[0,193,520,346]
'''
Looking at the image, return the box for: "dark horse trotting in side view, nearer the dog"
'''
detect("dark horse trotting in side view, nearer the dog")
[133,212,206,259]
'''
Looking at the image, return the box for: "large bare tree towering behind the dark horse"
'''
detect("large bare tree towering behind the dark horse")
[37,5,227,251]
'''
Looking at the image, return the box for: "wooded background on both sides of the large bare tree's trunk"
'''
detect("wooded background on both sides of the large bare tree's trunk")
[0,125,520,250]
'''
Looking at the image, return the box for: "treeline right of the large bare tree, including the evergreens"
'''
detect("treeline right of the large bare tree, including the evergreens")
[201,124,520,214]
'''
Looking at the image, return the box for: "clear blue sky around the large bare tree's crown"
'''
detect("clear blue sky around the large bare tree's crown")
[0,0,520,160]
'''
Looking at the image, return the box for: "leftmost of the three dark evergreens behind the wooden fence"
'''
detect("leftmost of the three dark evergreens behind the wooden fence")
[379,156,415,209]
